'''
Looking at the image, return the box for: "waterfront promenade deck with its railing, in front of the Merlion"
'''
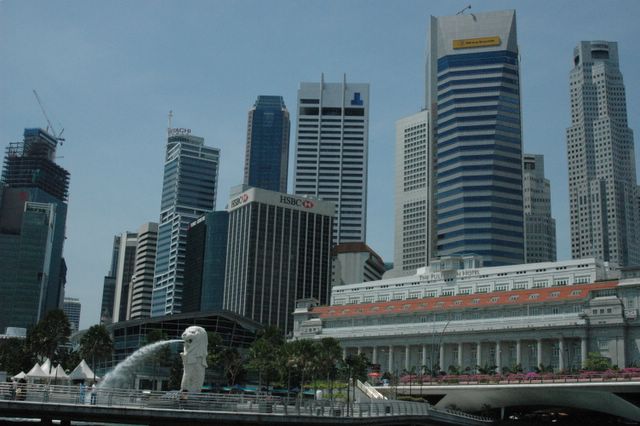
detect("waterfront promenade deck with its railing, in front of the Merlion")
[0,384,493,426]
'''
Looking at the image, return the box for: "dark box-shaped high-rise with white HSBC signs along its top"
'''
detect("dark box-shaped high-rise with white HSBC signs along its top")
[223,188,335,334]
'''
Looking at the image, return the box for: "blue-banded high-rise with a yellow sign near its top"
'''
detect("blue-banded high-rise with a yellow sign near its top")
[427,10,524,266]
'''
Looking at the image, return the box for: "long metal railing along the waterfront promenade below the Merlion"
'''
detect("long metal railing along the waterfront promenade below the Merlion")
[0,383,492,423]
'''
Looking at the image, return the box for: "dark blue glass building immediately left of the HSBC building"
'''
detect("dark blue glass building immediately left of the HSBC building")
[182,211,229,312]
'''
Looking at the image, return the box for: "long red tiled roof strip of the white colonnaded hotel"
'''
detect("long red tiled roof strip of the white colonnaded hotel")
[312,280,618,318]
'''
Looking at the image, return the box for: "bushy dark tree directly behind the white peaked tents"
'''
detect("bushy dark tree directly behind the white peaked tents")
[27,309,71,362]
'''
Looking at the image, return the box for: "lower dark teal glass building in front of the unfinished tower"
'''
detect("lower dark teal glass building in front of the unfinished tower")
[0,201,57,332]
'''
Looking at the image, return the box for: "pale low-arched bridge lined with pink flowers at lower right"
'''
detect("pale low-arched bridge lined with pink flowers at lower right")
[376,375,640,422]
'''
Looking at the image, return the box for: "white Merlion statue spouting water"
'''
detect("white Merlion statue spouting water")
[180,325,208,392]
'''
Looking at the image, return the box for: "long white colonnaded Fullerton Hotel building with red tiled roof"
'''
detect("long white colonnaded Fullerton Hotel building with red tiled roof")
[294,256,640,372]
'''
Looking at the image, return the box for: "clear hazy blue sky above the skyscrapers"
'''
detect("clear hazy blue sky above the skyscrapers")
[0,0,640,328]
